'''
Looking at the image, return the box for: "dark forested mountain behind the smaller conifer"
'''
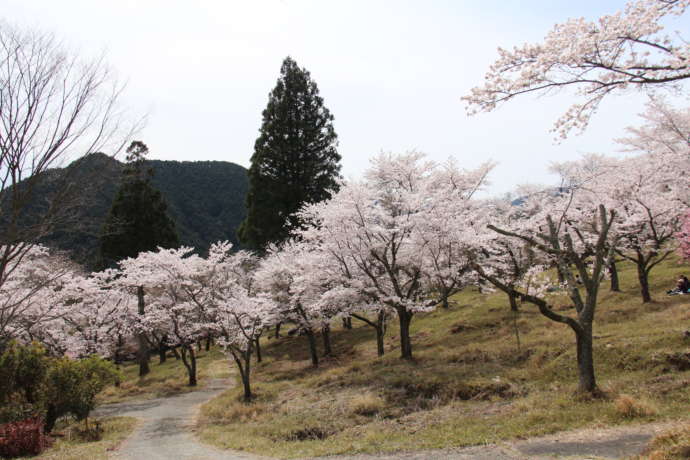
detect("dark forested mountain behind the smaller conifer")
[42,153,247,266]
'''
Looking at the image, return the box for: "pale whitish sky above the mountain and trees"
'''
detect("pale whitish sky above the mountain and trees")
[5,0,690,195]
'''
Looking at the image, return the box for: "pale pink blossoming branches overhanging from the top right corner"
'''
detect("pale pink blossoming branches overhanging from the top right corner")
[463,0,690,138]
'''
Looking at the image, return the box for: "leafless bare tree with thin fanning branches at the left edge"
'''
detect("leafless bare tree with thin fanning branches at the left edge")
[0,21,135,344]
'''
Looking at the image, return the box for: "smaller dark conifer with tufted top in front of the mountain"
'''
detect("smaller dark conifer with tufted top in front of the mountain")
[100,141,180,267]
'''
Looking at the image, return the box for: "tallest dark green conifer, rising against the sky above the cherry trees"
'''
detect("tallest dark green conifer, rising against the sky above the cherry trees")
[237,57,340,250]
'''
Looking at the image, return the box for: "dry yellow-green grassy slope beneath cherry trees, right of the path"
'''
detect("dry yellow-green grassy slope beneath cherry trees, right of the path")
[194,261,690,457]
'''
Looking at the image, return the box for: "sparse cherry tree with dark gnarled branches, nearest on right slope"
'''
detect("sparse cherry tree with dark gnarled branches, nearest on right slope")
[474,165,616,393]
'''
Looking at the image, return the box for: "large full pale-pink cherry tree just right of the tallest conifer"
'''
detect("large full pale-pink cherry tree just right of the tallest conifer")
[299,152,490,359]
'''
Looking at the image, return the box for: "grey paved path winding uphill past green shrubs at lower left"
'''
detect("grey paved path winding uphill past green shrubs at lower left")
[94,380,259,460]
